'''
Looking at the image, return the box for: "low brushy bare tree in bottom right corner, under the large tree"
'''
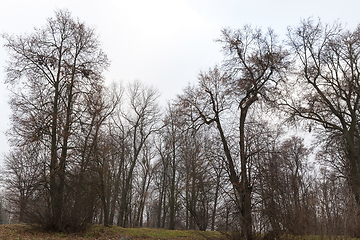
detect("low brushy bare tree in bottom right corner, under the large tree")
[316,139,360,237]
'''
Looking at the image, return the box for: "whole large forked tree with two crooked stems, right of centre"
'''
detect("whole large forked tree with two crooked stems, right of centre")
[183,26,288,239]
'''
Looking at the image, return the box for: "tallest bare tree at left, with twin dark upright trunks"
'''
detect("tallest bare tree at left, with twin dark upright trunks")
[3,10,109,230]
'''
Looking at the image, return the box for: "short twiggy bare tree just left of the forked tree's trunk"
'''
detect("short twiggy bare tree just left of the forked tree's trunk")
[180,128,214,231]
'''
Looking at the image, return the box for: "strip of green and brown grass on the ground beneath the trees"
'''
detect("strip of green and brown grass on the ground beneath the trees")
[0,224,224,240]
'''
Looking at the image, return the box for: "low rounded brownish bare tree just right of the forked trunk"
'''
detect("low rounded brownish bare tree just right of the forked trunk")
[262,136,317,235]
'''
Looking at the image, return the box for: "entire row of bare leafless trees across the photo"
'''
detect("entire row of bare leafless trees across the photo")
[1,10,360,240]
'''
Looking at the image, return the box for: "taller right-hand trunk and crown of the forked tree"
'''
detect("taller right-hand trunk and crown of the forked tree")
[219,26,289,239]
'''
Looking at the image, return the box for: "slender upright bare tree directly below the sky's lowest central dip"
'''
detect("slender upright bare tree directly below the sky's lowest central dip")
[145,104,185,229]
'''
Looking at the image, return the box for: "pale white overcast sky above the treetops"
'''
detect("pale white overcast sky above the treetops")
[0,0,360,158]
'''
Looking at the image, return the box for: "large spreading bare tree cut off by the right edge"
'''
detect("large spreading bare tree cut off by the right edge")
[283,19,360,206]
